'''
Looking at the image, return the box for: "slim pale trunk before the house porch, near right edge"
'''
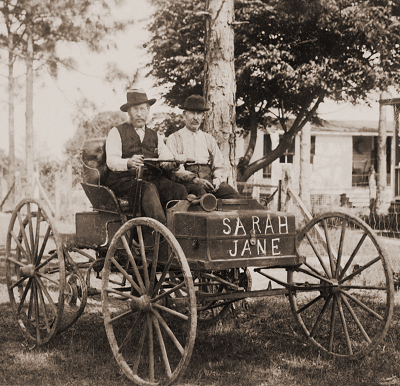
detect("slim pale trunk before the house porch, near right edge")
[375,92,390,213]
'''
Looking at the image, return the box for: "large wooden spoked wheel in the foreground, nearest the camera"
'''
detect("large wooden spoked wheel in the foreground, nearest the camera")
[102,217,197,385]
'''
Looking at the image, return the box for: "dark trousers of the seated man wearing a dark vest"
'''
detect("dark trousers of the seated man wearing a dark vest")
[110,176,187,225]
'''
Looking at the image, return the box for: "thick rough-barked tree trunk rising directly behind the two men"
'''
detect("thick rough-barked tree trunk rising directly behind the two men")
[204,0,236,183]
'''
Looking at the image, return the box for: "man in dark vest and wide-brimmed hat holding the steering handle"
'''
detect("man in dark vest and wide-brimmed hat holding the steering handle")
[106,89,187,224]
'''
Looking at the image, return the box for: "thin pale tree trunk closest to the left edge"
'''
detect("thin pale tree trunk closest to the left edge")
[8,34,16,205]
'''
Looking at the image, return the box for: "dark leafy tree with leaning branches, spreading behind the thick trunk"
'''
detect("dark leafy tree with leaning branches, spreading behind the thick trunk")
[148,0,400,180]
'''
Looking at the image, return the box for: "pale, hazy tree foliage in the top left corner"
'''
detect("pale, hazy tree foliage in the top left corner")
[0,0,131,71]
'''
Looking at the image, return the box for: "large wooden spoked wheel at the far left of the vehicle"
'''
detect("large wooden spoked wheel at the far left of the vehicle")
[6,198,65,344]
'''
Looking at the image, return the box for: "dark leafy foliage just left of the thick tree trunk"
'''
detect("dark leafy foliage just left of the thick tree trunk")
[147,0,205,106]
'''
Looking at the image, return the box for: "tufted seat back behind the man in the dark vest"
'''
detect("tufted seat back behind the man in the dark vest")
[82,138,109,185]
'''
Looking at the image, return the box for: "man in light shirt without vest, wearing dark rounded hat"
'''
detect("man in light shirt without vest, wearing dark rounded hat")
[167,95,241,198]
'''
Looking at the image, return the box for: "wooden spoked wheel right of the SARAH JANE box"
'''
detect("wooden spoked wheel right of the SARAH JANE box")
[288,212,394,359]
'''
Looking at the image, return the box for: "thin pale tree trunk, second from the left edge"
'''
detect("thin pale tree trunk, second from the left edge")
[25,24,34,192]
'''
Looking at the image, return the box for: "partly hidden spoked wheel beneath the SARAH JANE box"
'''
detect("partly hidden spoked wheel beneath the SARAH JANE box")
[194,268,252,328]
